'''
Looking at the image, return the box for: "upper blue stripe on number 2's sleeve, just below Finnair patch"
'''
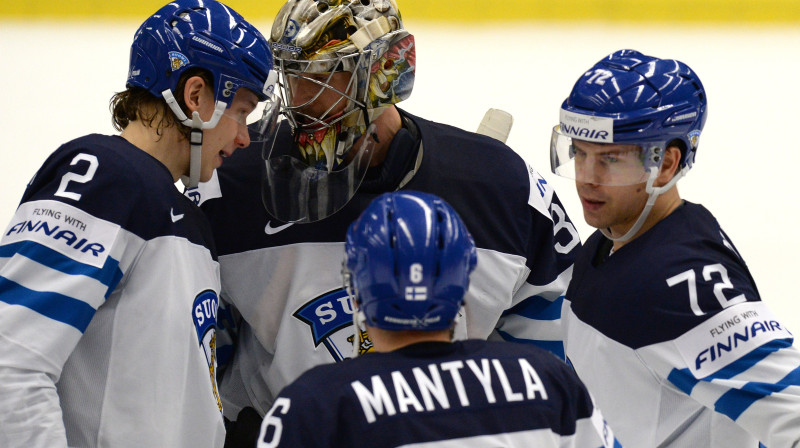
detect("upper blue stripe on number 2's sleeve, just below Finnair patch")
[0,241,122,298]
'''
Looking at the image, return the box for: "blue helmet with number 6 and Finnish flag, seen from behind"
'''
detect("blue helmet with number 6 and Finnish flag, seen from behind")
[344,191,477,330]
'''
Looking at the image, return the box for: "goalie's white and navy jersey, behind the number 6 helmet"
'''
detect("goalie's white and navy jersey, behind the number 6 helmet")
[194,111,580,419]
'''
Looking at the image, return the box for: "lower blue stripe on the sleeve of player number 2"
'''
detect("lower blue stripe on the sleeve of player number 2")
[0,277,96,333]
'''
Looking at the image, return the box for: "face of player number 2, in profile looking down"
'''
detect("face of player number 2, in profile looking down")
[200,88,258,182]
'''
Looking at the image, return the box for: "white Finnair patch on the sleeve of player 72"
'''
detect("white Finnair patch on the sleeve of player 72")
[675,302,792,379]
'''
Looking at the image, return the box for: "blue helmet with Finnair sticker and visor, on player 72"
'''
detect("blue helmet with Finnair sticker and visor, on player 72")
[550,50,707,185]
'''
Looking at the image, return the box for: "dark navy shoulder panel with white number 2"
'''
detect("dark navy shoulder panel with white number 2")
[21,134,213,248]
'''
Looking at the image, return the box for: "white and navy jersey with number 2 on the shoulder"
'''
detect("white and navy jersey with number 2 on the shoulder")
[0,135,225,448]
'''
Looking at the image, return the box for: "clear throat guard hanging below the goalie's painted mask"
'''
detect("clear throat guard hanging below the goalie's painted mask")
[261,124,375,223]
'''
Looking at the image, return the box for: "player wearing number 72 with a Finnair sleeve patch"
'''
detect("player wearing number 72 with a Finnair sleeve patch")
[551,50,800,448]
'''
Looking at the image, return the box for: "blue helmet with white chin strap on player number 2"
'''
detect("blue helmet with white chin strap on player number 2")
[126,0,280,188]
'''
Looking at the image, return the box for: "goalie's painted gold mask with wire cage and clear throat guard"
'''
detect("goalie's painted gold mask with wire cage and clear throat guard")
[262,0,416,222]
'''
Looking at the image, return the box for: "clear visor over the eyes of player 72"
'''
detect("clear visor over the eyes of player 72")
[550,126,664,186]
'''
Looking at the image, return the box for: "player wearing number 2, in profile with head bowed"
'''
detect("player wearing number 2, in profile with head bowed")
[0,0,278,448]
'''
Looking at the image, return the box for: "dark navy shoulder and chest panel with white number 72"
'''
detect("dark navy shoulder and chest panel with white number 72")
[567,202,760,348]
